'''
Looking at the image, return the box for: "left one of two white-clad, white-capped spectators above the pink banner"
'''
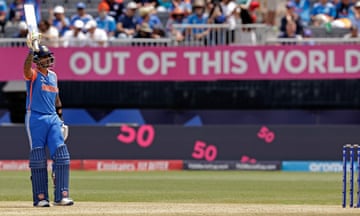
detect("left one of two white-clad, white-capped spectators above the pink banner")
[61,19,86,47]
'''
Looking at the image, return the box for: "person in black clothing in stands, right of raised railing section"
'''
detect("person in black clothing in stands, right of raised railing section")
[280,1,304,35]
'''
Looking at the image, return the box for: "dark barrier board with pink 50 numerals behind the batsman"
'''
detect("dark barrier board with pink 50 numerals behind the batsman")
[0,125,360,161]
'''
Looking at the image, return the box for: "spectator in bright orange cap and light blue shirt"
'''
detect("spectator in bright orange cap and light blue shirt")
[95,4,116,39]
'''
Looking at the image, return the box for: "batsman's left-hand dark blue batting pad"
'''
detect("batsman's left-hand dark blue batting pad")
[29,148,49,205]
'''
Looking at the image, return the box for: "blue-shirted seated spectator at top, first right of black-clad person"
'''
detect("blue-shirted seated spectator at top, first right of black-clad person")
[311,0,336,22]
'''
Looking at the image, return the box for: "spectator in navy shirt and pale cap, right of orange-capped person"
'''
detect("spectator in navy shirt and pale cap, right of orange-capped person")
[116,2,140,38]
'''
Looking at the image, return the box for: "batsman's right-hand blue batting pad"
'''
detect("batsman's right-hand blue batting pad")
[54,145,70,202]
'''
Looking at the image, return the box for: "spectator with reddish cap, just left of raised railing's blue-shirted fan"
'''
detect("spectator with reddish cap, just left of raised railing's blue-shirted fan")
[166,8,185,42]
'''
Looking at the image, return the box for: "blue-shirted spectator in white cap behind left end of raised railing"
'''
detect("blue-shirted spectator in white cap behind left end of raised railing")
[186,0,210,44]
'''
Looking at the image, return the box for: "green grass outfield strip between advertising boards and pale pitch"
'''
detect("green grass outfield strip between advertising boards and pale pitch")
[0,171,360,215]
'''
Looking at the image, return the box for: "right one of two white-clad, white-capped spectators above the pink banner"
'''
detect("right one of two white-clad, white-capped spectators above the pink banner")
[85,20,108,47]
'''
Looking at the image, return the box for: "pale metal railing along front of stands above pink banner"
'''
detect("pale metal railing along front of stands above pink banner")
[0,24,354,47]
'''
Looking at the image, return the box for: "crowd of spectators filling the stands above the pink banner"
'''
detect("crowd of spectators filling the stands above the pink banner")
[0,0,360,47]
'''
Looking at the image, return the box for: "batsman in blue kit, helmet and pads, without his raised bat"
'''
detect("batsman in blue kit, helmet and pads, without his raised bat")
[24,33,74,207]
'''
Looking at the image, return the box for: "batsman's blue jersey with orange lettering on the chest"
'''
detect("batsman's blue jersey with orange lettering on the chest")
[26,70,59,114]
